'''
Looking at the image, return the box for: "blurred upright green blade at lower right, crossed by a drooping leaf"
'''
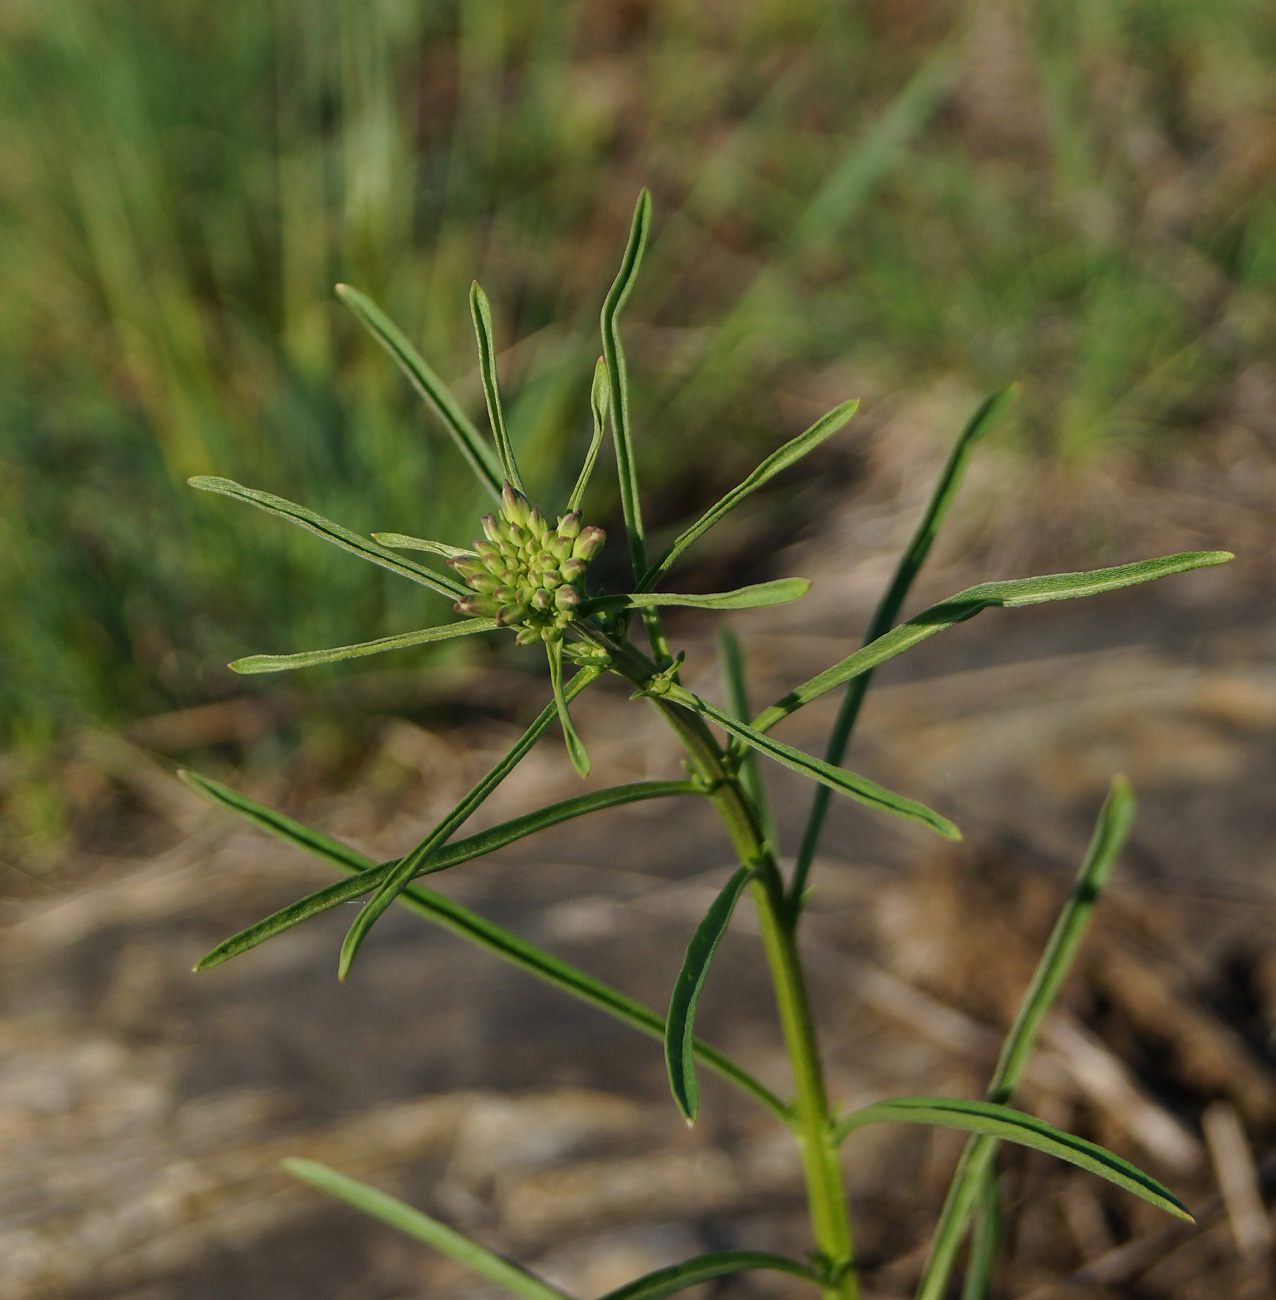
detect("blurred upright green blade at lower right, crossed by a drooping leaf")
[917,776,1137,1300]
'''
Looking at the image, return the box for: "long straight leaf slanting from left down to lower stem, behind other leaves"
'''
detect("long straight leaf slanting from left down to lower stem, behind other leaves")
[182,769,791,1123]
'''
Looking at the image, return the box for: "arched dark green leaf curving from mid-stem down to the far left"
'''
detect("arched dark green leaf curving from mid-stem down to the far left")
[194,774,703,971]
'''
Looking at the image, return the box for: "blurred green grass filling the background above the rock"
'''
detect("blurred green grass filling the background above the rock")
[0,0,1276,745]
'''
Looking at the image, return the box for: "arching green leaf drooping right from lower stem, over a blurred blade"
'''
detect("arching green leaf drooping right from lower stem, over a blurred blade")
[833,1097,1192,1222]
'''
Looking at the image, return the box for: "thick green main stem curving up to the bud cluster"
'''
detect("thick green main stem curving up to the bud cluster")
[589,624,859,1300]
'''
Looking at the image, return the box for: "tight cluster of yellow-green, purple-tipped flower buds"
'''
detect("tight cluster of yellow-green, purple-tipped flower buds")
[448,484,606,645]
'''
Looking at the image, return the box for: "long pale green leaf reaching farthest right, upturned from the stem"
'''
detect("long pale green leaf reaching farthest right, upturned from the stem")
[754,551,1233,732]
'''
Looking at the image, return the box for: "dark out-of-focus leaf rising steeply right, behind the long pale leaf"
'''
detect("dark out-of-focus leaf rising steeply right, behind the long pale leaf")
[787,385,1015,920]
